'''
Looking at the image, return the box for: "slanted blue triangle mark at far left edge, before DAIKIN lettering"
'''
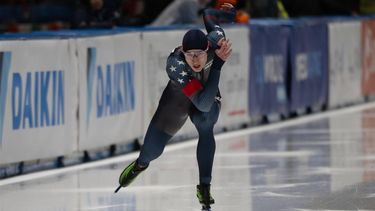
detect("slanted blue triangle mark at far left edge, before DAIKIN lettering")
[0,52,12,147]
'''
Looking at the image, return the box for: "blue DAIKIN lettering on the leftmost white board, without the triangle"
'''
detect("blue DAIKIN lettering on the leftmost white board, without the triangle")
[10,70,65,130]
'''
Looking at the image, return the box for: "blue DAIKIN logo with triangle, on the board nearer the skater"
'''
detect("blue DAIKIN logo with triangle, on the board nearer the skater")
[86,48,135,126]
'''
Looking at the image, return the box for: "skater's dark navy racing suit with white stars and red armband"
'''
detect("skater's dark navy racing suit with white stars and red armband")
[138,9,234,184]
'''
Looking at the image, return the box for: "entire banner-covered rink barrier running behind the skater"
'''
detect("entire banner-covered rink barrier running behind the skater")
[0,18,375,178]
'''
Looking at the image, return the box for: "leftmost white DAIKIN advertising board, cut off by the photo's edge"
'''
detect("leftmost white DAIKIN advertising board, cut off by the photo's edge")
[0,39,78,164]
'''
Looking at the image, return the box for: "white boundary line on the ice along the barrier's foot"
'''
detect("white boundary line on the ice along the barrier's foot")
[0,102,375,186]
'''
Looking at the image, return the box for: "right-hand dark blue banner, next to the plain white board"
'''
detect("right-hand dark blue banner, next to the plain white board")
[290,20,328,111]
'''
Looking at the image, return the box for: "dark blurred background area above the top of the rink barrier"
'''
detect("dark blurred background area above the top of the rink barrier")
[0,0,375,33]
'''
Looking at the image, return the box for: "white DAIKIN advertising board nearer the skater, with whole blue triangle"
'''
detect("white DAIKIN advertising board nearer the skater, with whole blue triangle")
[77,33,144,150]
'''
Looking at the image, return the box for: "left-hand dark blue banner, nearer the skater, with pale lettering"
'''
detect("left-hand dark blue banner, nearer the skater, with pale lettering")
[249,21,290,116]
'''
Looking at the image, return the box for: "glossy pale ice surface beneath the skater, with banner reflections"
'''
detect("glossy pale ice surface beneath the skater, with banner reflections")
[0,103,375,211]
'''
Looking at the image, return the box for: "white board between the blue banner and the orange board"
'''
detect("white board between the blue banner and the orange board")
[328,21,362,108]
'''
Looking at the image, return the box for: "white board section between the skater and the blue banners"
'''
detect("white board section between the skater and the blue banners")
[216,27,250,128]
